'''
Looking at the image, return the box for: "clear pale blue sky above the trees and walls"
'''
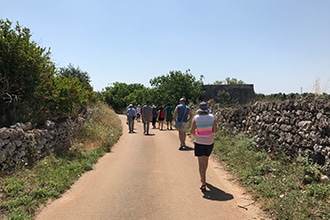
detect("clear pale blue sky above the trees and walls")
[0,0,330,94]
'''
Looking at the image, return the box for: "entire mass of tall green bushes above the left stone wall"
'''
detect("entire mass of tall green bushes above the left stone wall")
[0,19,97,127]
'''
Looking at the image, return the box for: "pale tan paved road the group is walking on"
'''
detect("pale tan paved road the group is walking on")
[36,116,266,220]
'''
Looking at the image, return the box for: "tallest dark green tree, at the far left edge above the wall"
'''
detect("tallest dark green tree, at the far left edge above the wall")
[0,19,55,126]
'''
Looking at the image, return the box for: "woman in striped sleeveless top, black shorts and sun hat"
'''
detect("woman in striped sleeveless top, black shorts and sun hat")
[190,102,217,191]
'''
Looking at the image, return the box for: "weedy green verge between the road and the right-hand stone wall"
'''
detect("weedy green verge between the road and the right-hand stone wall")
[214,132,330,220]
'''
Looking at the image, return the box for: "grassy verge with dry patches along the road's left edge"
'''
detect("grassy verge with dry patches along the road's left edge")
[0,104,122,220]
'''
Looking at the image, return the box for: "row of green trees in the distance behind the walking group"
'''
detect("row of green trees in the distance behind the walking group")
[102,70,204,113]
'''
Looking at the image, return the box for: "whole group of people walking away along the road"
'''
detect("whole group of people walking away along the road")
[126,98,217,191]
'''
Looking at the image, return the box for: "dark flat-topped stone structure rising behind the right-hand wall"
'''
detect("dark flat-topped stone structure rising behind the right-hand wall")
[203,84,255,104]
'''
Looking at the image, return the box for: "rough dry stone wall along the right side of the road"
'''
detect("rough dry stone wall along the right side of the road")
[212,100,330,176]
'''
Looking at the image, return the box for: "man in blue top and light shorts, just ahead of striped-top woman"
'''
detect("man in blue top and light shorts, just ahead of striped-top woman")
[173,98,192,150]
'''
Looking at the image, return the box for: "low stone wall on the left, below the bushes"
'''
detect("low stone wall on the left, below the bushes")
[0,109,98,173]
